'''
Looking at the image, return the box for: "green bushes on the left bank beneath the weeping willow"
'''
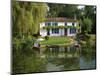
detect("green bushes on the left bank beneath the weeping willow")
[12,36,35,53]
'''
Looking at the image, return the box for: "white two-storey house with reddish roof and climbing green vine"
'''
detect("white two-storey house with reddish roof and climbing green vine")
[40,18,78,36]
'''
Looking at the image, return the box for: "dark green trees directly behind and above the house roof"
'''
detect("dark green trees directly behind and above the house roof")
[48,3,77,18]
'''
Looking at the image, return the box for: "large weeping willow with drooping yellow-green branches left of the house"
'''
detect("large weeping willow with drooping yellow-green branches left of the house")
[12,1,47,36]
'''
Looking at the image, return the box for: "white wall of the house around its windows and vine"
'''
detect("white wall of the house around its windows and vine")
[40,22,77,36]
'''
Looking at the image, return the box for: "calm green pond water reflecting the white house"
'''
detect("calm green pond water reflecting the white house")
[12,45,96,73]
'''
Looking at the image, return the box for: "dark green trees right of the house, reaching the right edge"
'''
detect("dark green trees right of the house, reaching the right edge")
[76,6,96,34]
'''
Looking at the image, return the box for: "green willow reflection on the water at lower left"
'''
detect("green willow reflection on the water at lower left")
[12,50,46,75]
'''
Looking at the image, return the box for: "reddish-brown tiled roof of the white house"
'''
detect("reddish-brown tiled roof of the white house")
[45,17,77,22]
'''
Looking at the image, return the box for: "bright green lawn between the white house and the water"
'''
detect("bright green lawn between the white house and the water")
[40,36,74,45]
